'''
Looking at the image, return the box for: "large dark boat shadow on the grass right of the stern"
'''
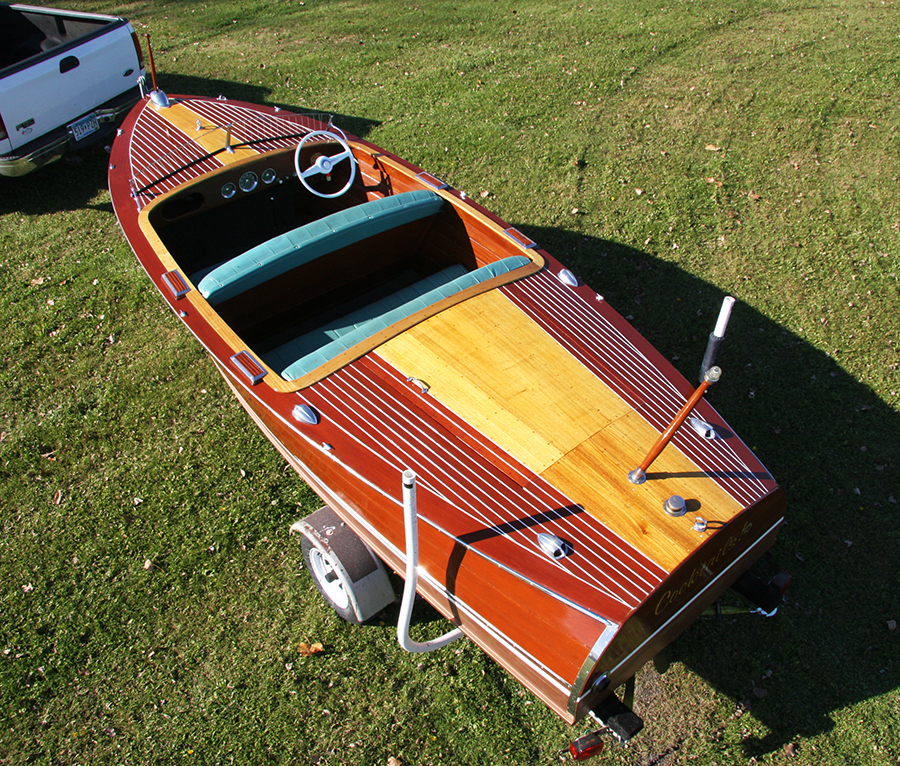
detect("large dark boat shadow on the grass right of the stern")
[520,225,900,757]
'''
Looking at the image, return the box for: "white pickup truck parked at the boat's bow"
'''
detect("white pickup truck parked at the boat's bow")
[0,3,144,176]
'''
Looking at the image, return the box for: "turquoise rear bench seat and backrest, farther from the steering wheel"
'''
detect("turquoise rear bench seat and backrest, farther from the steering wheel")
[263,255,531,380]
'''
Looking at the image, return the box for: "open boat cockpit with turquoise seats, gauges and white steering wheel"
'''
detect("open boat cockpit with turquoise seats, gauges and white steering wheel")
[141,132,542,386]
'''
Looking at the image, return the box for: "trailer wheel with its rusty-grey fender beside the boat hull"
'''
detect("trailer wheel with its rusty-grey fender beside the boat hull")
[291,506,396,625]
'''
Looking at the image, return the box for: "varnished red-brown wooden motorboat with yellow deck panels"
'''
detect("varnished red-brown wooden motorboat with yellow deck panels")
[109,85,784,744]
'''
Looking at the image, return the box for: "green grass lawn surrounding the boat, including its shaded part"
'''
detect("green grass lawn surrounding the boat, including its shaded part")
[0,0,900,766]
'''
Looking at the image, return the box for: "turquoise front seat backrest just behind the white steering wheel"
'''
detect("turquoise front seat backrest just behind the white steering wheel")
[197,189,443,305]
